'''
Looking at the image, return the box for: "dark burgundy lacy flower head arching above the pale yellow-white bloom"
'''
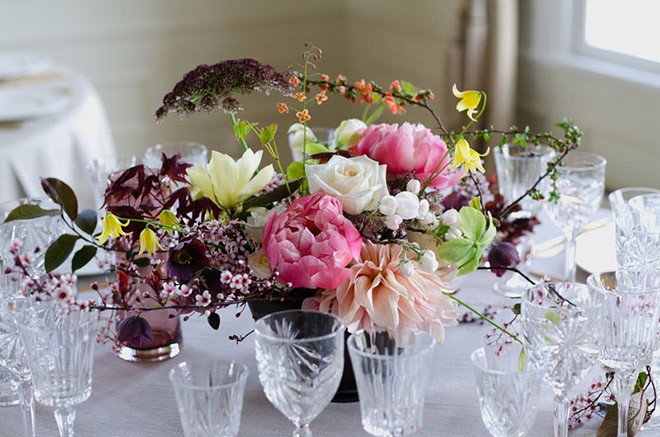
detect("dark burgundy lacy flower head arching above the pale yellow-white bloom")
[155,58,292,121]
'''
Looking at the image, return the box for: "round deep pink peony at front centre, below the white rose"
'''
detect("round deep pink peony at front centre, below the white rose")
[263,191,362,288]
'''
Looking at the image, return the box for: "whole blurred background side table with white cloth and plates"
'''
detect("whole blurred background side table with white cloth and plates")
[0,53,115,207]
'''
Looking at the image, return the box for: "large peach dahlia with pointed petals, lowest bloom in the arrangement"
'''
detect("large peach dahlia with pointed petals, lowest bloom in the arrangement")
[303,241,458,343]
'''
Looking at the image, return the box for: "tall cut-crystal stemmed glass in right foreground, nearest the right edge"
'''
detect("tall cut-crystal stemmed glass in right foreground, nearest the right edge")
[587,270,660,437]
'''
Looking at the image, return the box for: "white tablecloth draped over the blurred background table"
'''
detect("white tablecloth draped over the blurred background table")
[0,68,115,207]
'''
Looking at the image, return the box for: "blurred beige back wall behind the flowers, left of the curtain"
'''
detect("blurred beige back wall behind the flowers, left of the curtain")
[0,0,460,162]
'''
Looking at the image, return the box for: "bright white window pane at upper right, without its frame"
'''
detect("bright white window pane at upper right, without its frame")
[585,0,660,62]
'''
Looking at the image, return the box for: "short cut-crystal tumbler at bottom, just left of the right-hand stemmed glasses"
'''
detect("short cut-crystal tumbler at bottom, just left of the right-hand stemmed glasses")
[471,346,543,437]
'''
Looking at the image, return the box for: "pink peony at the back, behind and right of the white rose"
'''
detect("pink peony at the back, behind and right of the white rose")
[351,123,461,189]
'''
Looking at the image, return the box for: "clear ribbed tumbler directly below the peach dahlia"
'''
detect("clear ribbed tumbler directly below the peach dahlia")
[347,330,435,436]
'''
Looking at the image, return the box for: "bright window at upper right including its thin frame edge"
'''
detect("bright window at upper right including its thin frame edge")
[576,0,660,68]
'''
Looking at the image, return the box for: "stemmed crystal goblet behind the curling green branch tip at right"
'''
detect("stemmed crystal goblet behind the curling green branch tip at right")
[545,151,607,282]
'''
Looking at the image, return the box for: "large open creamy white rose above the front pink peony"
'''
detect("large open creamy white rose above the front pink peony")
[306,155,387,215]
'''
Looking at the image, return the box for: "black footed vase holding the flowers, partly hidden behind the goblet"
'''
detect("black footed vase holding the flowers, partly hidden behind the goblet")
[248,290,359,403]
